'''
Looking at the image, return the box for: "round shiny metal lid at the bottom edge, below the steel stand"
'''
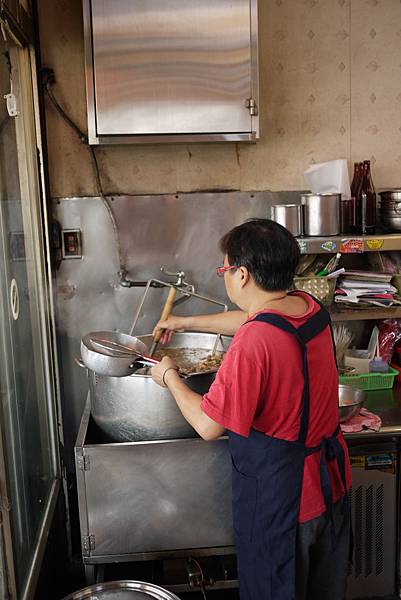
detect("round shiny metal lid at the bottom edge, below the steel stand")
[64,580,179,600]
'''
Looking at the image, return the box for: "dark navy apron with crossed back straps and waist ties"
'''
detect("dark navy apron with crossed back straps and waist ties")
[228,307,347,600]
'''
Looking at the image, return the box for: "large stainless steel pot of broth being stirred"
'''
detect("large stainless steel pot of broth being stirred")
[88,333,231,442]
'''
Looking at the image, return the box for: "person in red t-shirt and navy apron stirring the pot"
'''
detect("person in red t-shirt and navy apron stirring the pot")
[152,219,351,600]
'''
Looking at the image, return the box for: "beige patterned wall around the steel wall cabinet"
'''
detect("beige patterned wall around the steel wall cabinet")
[38,0,401,196]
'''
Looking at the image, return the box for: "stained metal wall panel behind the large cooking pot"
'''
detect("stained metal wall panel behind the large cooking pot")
[54,192,299,470]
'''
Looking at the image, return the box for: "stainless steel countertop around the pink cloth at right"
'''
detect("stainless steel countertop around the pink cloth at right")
[344,383,401,443]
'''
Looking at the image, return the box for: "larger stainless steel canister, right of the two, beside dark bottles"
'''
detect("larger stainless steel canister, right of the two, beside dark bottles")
[301,194,341,235]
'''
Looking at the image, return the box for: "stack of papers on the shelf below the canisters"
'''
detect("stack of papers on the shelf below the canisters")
[335,271,401,308]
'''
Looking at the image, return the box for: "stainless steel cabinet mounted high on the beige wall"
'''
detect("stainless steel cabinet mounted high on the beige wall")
[83,0,259,144]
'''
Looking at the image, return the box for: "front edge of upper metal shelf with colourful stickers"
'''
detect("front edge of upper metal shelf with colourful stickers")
[297,233,401,254]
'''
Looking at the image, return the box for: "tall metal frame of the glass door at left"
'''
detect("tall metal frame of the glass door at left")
[0,14,63,600]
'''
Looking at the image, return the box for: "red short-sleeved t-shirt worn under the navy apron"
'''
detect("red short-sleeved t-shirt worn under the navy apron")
[201,292,351,522]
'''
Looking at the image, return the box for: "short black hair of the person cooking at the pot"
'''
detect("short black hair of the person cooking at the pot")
[220,219,300,292]
